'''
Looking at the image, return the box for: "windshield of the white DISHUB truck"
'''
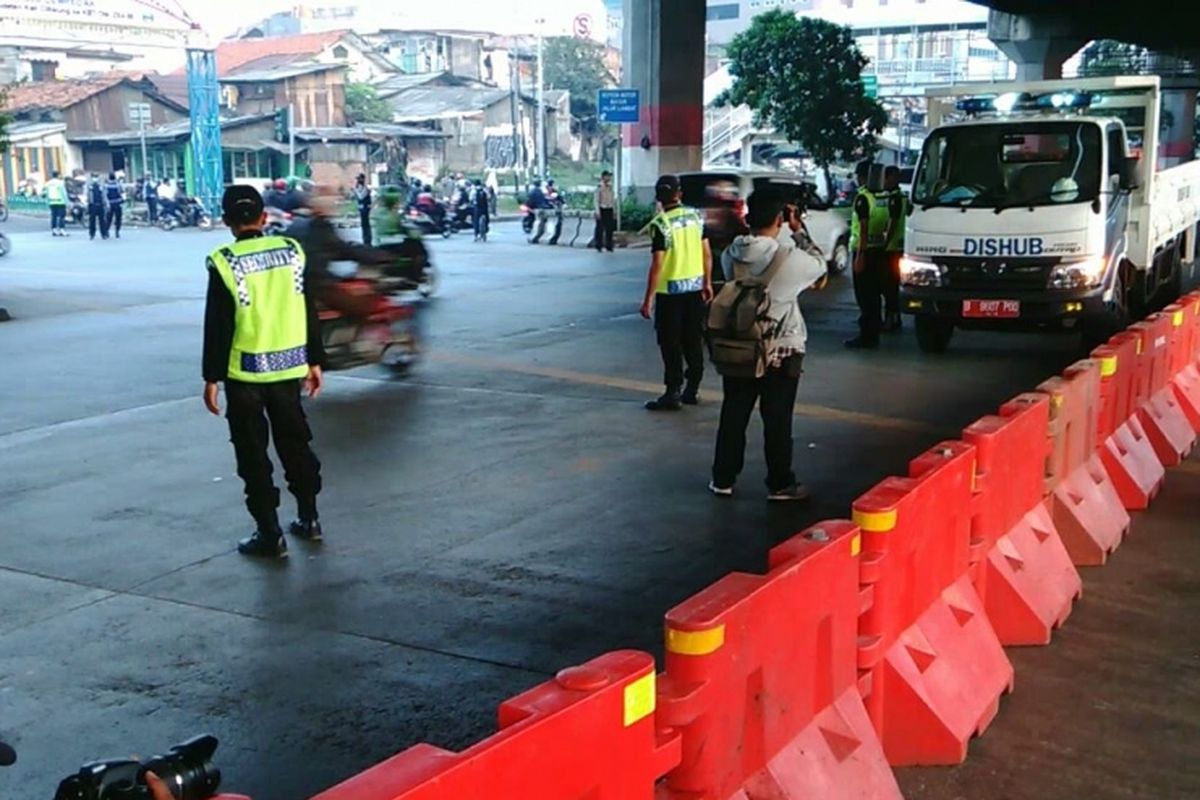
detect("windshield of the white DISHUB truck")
[912,121,1100,209]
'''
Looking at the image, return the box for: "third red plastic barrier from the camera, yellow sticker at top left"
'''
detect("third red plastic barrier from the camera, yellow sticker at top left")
[854,441,1013,766]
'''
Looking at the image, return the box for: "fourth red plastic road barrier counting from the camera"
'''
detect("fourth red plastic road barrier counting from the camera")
[962,395,1084,644]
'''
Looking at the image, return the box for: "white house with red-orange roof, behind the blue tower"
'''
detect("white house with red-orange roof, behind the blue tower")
[217,30,396,83]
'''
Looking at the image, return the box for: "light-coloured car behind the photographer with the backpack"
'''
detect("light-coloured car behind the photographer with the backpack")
[679,169,850,284]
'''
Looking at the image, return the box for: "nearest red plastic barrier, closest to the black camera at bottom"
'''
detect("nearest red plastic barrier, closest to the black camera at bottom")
[314,650,679,800]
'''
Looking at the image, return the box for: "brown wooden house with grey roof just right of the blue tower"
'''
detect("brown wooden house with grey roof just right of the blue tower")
[220,59,346,127]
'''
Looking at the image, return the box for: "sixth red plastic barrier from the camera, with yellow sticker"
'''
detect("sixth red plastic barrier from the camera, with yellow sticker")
[1092,331,1166,510]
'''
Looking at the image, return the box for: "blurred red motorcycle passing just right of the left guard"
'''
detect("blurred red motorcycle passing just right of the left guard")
[317,272,421,377]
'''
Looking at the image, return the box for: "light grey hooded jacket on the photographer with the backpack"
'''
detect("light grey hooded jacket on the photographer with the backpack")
[721,235,827,353]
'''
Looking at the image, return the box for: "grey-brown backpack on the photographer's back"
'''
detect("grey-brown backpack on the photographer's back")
[706,247,791,378]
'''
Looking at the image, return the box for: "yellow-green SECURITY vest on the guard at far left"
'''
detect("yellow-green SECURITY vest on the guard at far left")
[209,236,308,384]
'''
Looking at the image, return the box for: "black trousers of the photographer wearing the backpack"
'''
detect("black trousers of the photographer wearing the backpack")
[713,354,804,492]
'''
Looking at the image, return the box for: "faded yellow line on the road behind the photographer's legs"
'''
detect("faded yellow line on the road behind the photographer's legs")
[430,350,946,435]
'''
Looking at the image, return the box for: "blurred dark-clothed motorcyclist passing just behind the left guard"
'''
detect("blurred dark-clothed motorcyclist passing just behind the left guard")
[288,187,395,319]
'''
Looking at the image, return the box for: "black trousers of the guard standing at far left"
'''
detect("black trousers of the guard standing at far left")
[226,380,320,530]
